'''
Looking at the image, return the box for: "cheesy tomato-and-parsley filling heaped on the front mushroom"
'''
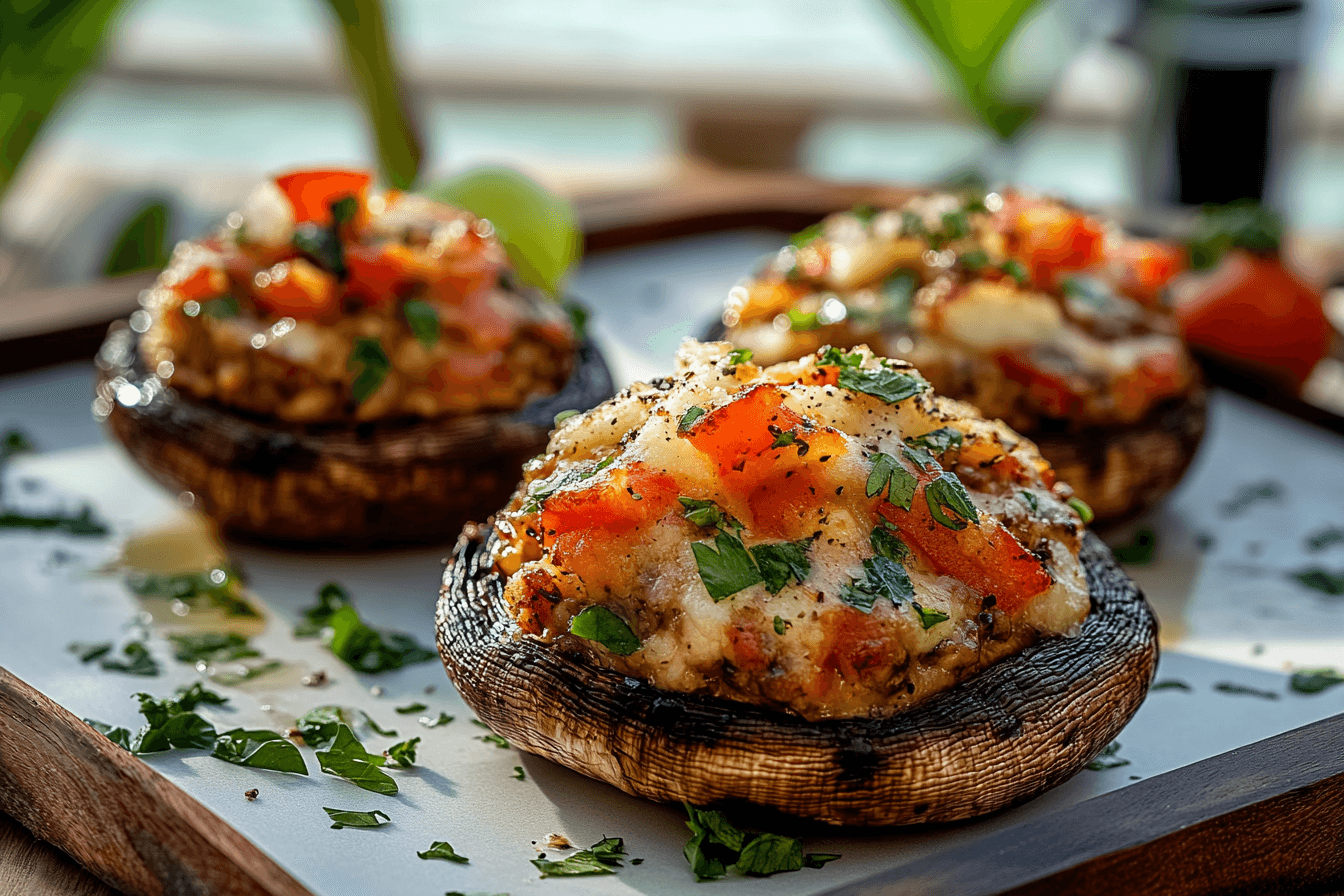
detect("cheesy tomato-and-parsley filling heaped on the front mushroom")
[492,341,1089,719]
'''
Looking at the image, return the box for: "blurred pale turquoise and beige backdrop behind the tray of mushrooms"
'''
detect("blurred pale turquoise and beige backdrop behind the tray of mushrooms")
[0,0,1344,294]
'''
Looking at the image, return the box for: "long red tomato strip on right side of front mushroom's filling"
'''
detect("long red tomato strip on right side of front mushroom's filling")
[878,483,1054,614]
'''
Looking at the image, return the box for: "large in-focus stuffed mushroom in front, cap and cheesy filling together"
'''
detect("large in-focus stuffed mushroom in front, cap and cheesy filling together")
[437,343,1157,825]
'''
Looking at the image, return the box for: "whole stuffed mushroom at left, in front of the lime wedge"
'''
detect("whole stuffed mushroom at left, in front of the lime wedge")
[94,171,613,547]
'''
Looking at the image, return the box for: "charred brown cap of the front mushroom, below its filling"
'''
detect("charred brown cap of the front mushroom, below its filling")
[435,527,1157,825]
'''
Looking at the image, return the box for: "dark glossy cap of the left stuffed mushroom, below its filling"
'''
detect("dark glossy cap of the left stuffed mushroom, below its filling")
[97,322,614,548]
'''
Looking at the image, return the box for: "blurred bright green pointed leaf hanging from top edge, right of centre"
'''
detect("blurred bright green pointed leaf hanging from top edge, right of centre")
[887,0,1040,140]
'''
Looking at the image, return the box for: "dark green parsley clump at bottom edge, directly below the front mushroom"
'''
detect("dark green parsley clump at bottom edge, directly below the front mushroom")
[681,803,840,881]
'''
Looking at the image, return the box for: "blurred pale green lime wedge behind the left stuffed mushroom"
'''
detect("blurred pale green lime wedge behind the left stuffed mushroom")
[429,167,583,296]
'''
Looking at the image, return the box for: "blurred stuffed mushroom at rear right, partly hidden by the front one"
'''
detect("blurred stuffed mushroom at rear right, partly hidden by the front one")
[720,192,1204,523]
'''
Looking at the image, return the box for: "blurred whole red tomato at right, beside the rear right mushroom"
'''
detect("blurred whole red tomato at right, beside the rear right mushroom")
[1176,250,1333,391]
